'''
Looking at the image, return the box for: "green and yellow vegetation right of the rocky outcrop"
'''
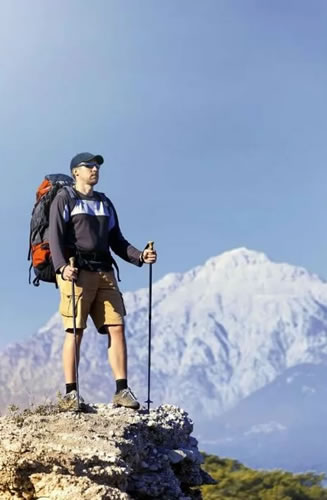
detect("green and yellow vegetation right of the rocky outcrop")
[201,453,327,500]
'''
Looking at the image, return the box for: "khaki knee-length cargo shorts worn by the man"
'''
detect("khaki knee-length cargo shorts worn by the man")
[57,269,126,333]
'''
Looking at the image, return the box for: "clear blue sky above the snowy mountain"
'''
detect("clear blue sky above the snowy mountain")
[0,0,327,347]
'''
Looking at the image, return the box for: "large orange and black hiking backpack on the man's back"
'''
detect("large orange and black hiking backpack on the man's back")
[28,174,76,286]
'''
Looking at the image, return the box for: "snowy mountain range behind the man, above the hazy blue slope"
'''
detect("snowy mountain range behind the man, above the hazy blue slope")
[0,248,327,472]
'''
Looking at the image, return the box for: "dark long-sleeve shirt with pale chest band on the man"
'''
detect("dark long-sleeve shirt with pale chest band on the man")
[49,189,142,272]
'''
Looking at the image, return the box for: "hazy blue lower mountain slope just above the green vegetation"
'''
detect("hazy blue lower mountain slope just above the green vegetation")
[198,363,327,472]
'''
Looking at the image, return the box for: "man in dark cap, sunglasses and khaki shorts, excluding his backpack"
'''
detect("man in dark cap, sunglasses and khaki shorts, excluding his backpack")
[49,153,157,409]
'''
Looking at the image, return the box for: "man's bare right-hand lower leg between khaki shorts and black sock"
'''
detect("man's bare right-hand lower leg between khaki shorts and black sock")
[107,325,127,380]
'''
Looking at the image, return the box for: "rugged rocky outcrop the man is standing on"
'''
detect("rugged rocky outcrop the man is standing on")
[0,405,211,500]
